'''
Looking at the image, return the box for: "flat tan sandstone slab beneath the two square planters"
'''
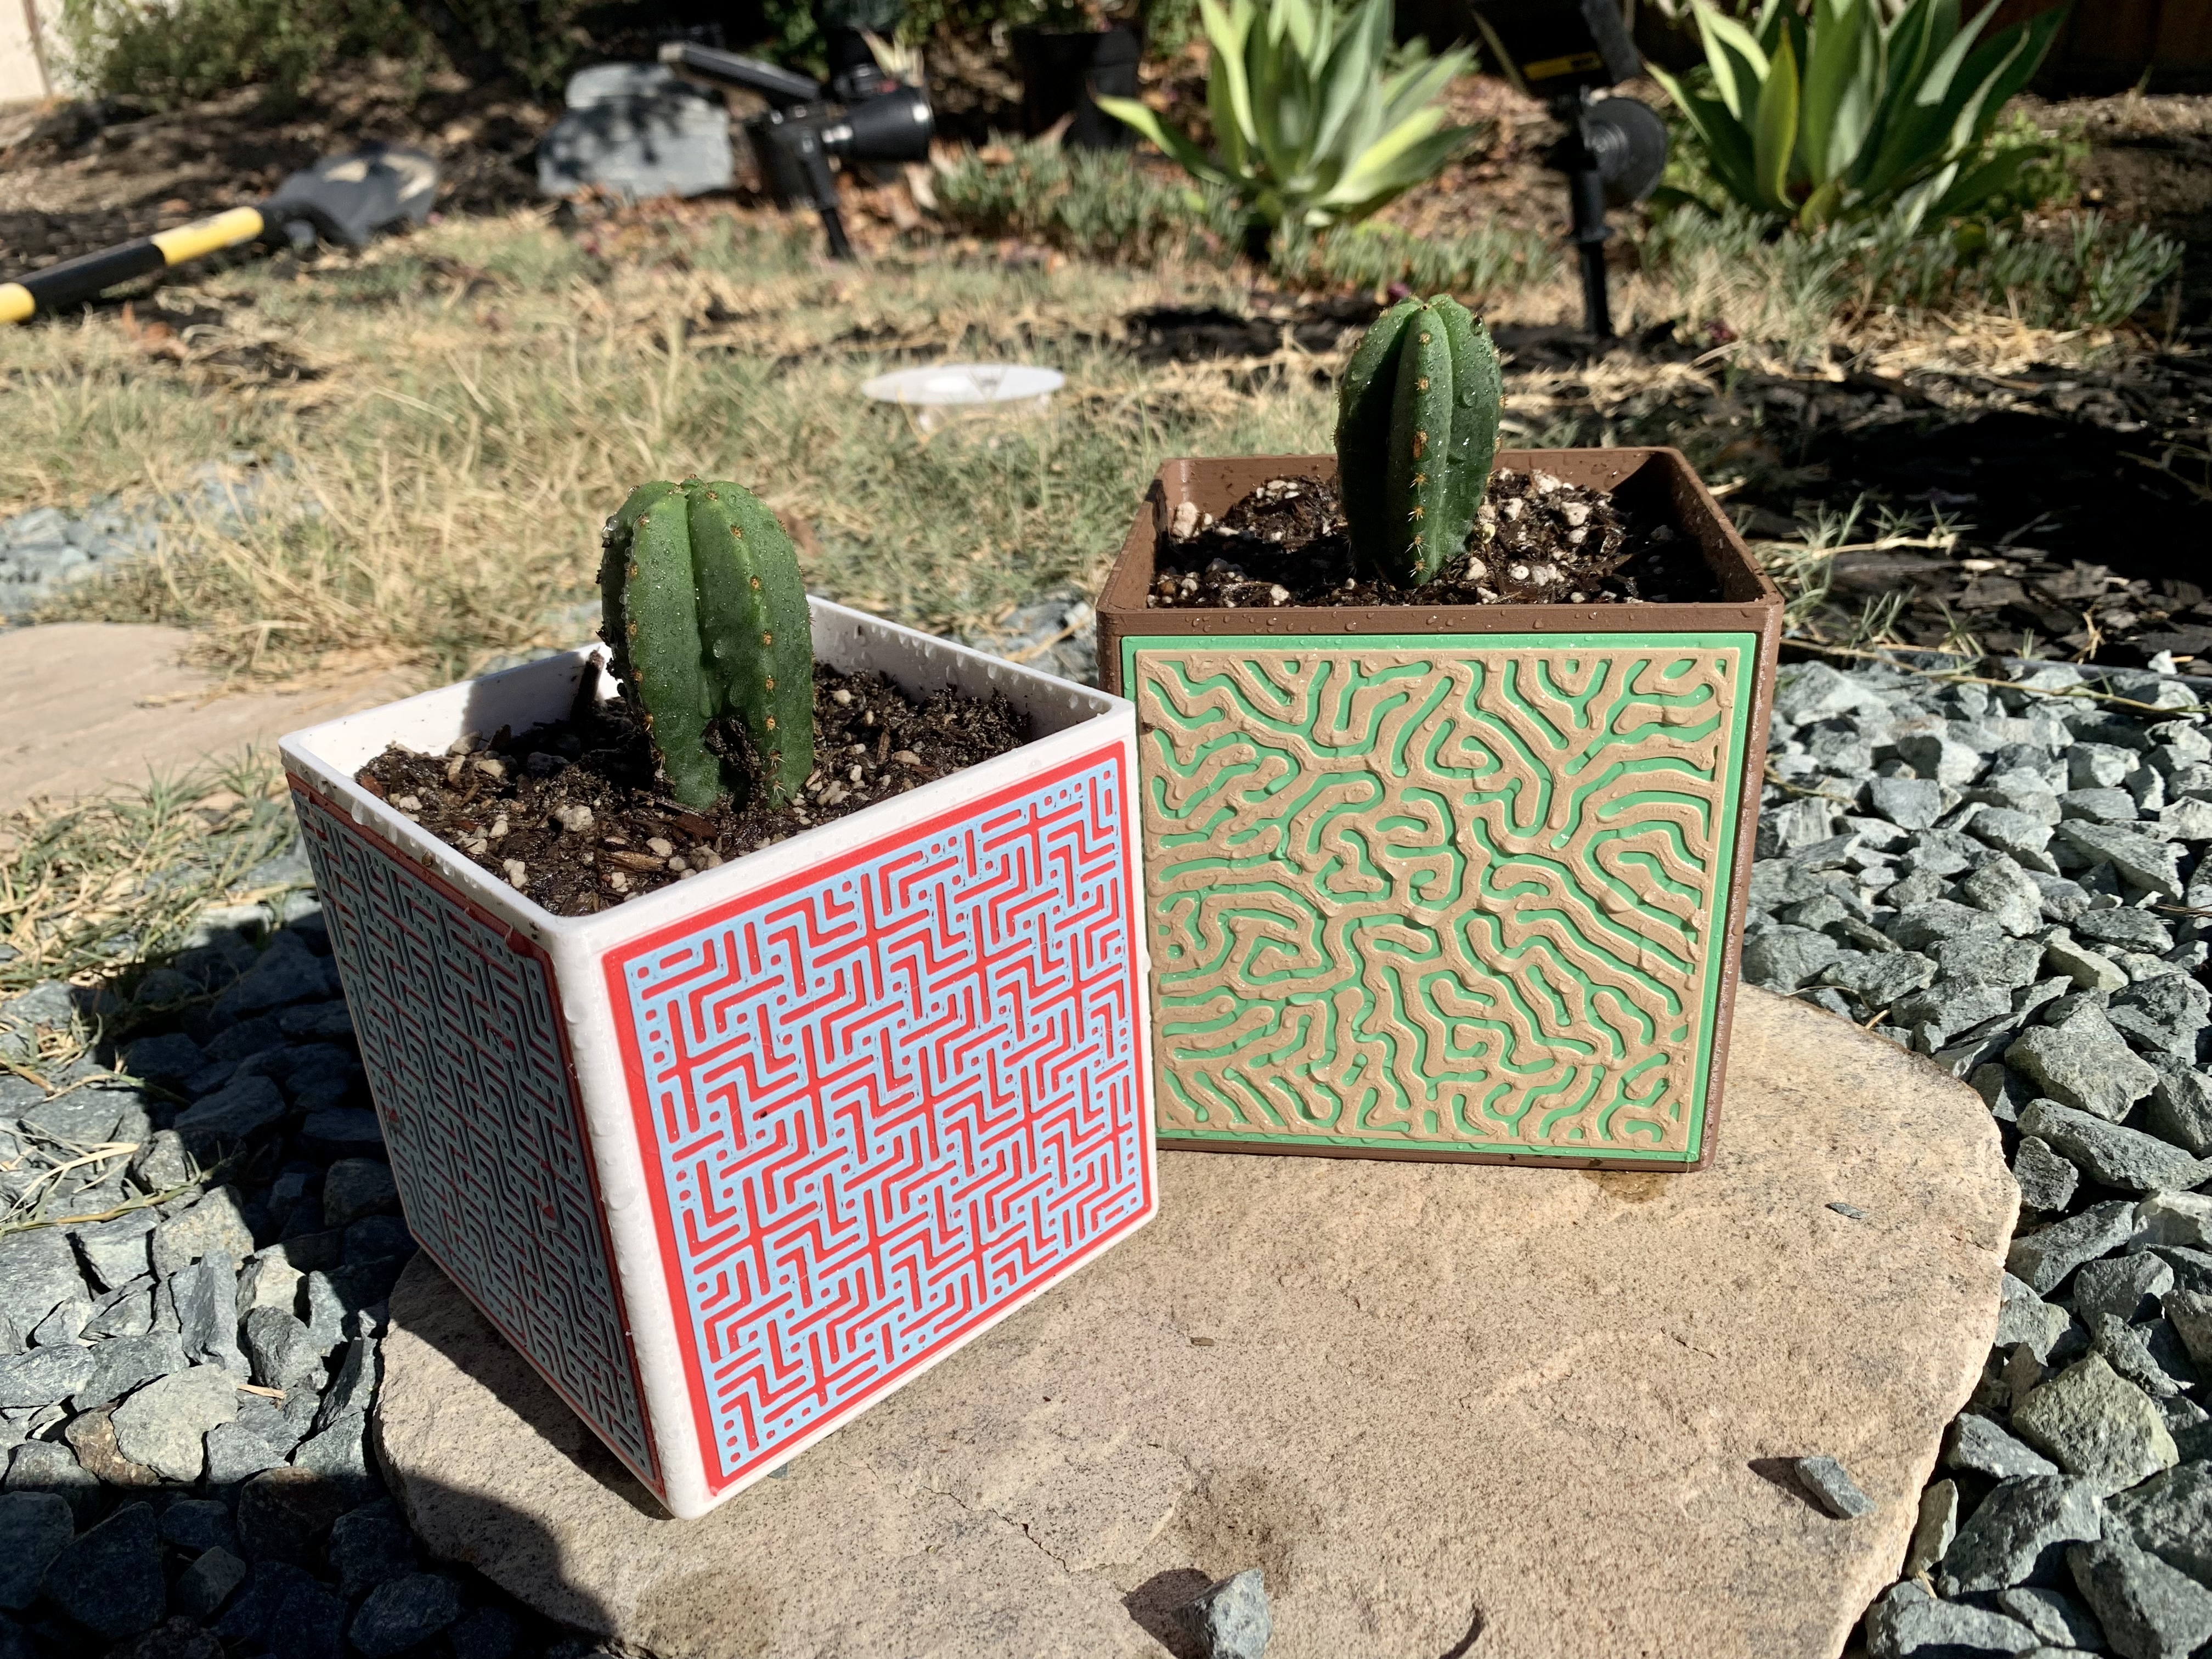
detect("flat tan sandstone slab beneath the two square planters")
[381,986,2015,1659]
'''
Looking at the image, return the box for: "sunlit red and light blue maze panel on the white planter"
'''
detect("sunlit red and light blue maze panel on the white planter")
[608,748,1153,1489]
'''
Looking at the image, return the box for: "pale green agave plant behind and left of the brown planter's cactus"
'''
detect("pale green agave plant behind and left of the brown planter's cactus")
[1097,0,1475,246]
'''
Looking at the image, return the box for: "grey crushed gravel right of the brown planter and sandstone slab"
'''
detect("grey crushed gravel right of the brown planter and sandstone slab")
[1743,662,2212,1659]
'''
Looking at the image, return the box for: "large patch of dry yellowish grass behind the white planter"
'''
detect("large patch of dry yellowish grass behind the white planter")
[0,215,1331,684]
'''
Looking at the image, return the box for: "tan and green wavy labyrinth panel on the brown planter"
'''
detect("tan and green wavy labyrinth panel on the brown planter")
[1124,635,1756,1161]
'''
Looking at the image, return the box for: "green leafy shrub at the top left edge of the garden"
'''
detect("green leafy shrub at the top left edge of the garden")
[62,0,431,109]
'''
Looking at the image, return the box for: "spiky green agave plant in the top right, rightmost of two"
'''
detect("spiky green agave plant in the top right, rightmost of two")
[1652,0,2066,230]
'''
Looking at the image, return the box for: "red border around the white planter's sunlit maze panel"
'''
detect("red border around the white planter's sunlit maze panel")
[602,741,1159,1498]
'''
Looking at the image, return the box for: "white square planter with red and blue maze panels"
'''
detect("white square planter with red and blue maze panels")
[281,600,1157,1517]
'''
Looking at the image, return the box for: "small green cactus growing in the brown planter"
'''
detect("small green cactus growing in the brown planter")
[1336,294,1504,589]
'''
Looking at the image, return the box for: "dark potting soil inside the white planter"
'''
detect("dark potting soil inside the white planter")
[356,664,1029,916]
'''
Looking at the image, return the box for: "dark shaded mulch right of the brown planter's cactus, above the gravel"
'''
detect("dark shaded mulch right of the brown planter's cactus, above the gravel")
[1451,325,2212,668]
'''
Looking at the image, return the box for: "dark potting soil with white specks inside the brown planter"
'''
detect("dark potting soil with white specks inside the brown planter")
[1144,471,1721,611]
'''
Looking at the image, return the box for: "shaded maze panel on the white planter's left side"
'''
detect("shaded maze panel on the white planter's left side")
[292,789,659,1491]
